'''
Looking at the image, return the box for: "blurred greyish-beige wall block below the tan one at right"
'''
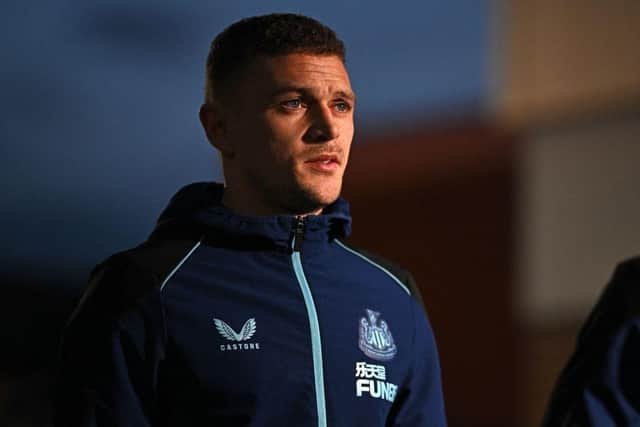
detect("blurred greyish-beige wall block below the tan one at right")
[519,114,640,324]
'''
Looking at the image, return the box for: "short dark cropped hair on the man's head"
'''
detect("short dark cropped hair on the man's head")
[205,13,345,102]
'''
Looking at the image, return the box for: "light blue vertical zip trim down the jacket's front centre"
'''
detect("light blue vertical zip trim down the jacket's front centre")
[291,237,327,427]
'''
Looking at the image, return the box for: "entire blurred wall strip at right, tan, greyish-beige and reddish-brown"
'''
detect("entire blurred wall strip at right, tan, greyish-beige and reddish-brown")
[500,0,640,426]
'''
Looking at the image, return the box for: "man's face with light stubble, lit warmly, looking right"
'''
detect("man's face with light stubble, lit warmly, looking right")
[215,54,355,214]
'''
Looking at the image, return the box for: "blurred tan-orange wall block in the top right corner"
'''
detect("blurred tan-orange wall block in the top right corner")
[495,0,640,124]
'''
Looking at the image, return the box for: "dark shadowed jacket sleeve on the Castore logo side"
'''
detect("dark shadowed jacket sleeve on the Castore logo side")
[54,256,164,427]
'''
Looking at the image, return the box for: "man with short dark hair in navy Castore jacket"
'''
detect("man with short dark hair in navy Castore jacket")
[56,14,445,427]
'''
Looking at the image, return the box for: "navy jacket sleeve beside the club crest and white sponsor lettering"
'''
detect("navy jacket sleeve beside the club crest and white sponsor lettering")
[392,303,447,427]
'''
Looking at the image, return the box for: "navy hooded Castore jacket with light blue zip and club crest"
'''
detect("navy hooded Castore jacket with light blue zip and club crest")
[55,184,446,427]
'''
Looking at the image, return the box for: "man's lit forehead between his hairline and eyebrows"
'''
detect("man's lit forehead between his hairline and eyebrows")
[244,53,352,94]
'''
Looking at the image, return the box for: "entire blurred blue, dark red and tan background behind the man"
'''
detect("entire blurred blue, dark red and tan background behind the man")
[0,0,640,427]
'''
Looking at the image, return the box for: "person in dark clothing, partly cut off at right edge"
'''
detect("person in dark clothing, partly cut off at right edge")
[543,257,640,427]
